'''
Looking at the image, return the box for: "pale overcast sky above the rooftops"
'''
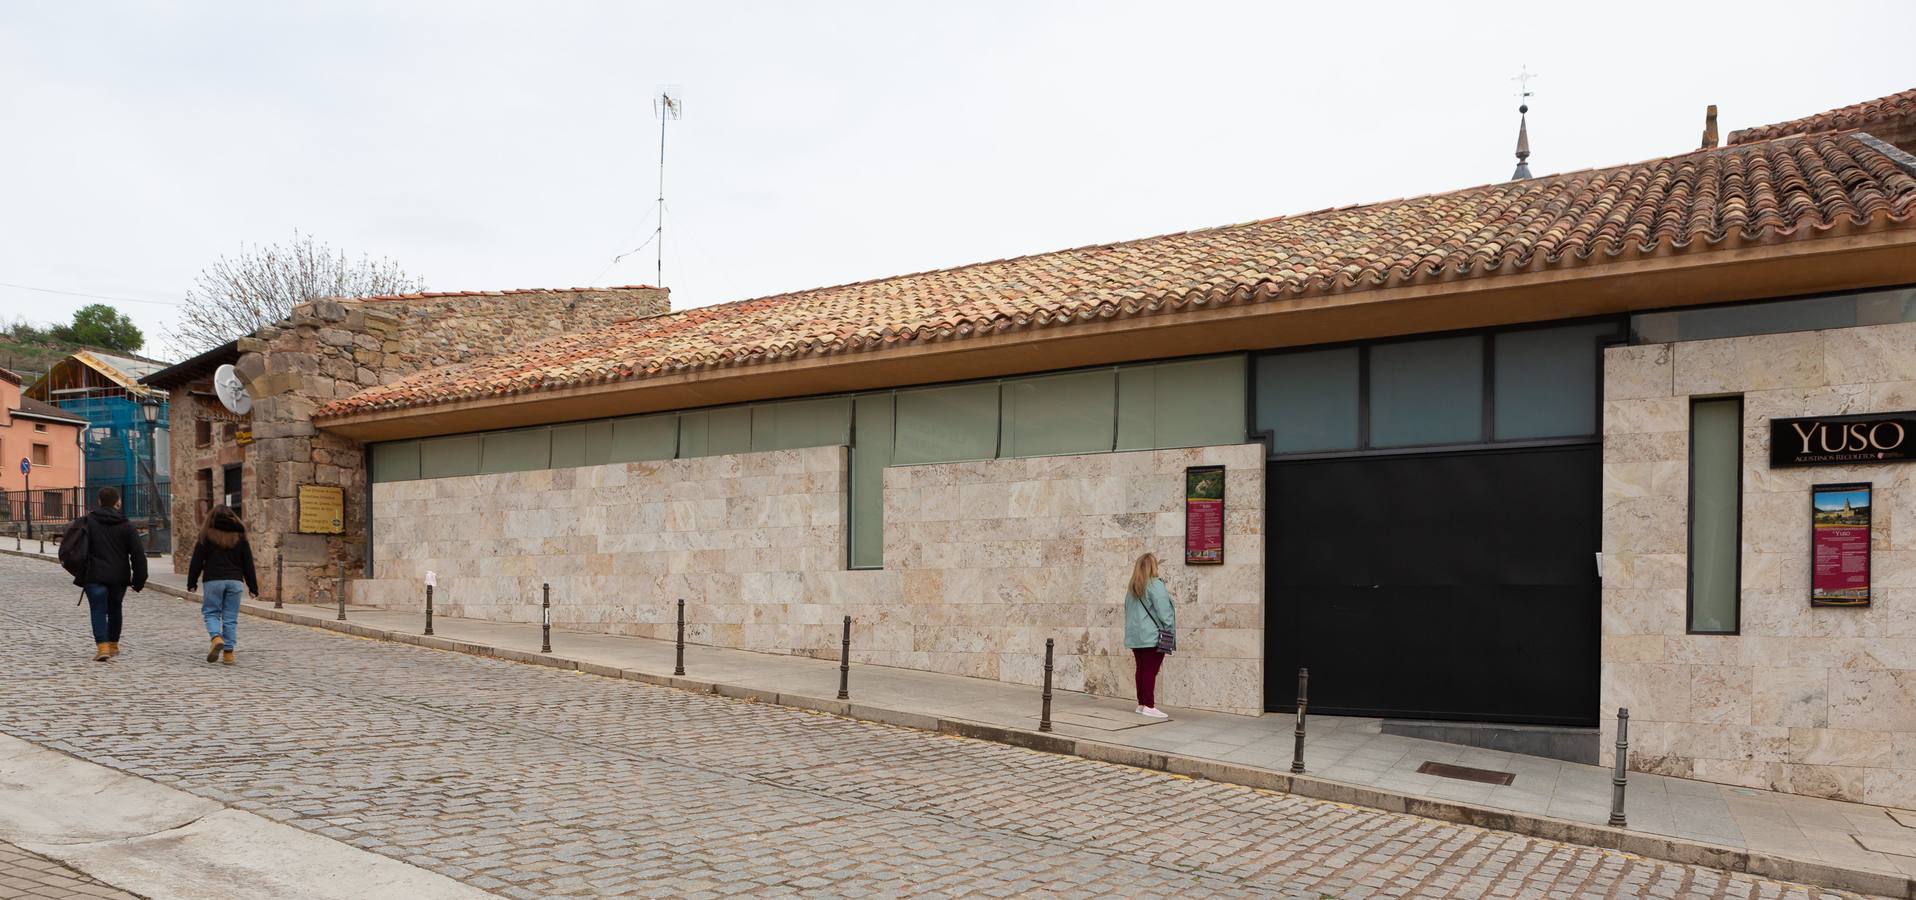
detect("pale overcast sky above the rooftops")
[0,0,1916,354]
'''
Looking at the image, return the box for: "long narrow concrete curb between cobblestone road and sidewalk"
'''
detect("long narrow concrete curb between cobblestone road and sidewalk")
[18,550,1916,900]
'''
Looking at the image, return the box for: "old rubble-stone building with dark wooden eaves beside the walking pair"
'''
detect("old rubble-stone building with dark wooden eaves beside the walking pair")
[142,285,669,601]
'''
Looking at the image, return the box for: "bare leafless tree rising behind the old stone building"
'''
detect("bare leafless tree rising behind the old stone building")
[169,230,425,352]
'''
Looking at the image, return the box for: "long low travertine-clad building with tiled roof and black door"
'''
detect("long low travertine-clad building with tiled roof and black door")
[149,84,1916,806]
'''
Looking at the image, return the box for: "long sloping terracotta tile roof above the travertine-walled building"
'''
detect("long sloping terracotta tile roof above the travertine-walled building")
[316,132,1916,417]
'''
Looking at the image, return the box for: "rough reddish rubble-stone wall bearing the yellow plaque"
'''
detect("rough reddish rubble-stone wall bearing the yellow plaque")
[206,287,669,603]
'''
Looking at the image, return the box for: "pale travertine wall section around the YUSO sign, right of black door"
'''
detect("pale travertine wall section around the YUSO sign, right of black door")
[1602,324,1916,806]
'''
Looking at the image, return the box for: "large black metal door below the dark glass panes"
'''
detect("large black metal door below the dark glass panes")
[1265,446,1602,726]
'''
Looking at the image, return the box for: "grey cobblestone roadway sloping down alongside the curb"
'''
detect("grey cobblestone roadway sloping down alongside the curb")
[0,557,1847,898]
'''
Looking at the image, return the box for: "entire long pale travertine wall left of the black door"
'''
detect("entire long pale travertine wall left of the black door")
[353,444,1265,714]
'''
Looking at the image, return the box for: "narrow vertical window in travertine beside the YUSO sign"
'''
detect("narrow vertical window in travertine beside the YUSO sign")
[1690,396,1744,634]
